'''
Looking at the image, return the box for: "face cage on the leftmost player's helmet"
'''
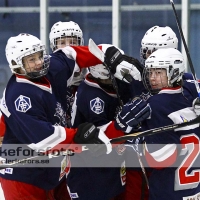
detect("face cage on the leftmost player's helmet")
[15,45,50,79]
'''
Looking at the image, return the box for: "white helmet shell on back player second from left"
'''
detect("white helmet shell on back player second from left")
[49,21,84,51]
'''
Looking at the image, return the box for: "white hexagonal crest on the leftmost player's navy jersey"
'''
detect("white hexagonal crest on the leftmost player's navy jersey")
[15,95,32,113]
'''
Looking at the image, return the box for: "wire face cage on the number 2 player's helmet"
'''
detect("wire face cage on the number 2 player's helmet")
[142,67,170,95]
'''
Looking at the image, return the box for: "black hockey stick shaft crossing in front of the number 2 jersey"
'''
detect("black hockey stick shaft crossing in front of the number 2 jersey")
[110,116,200,143]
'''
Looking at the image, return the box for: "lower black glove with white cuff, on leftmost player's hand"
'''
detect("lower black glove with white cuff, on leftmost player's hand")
[74,122,112,156]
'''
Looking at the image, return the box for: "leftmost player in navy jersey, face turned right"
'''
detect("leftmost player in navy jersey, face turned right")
[1,34,126,200]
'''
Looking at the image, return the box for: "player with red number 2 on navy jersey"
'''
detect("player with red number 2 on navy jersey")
[115,48,200,200]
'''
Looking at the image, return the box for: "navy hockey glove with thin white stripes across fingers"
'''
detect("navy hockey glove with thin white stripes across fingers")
[115,98,151,133]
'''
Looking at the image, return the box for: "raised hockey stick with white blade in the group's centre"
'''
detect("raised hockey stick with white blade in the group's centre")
[88,38,123,106]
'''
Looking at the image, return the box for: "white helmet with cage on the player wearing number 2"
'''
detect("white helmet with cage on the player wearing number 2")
[143,48,185,94]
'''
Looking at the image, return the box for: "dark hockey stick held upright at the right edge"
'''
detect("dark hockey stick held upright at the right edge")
[170,0,200,96]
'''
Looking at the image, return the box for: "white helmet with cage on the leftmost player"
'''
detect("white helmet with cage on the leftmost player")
[5,33,50,78]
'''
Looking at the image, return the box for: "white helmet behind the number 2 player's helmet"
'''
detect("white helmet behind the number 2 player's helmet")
[140,26,178,64]
